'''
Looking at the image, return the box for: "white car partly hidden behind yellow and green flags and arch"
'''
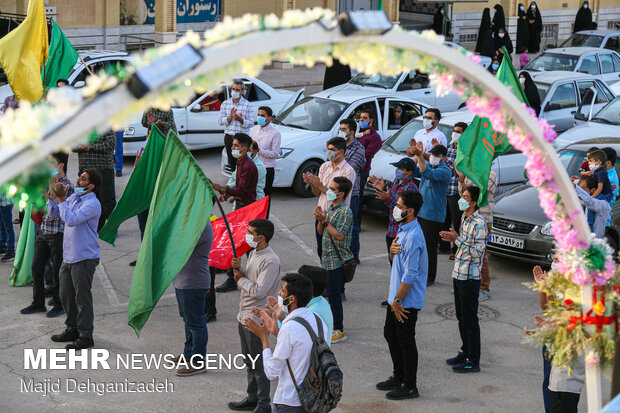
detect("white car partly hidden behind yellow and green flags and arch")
[0,50,131,112]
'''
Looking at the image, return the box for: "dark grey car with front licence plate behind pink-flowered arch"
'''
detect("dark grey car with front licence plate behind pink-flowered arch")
[487,136,620,267]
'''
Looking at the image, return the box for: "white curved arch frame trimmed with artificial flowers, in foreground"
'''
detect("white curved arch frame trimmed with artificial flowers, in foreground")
[0,24,601,413]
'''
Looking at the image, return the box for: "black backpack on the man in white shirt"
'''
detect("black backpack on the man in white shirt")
[286,314,342,413]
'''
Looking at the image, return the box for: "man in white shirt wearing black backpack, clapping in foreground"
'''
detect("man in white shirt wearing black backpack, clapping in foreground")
[245,273,327,413]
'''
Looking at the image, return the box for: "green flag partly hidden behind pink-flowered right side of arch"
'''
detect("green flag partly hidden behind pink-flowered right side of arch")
[456,48,529,207]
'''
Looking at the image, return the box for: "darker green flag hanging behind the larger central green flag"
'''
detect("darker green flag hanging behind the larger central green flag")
[99,125,166,245]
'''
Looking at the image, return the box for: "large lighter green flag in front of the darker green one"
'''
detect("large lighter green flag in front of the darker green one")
[128,132,215,336]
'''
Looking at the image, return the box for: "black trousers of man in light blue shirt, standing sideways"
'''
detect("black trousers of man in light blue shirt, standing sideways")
[383,306,419,389]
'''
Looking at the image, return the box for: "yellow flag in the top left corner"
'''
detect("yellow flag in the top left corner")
[0,0,49,103]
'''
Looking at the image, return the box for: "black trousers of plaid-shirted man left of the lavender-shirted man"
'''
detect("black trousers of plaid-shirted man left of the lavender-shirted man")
[32,231,63,307]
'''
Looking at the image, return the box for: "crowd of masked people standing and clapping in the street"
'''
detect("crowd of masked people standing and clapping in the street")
[0,75,618,412]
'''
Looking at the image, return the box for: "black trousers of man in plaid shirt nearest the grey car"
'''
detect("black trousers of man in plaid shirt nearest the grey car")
[452,279,480,366]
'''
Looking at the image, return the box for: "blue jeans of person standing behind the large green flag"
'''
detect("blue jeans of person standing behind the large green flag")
[175,288,209,359]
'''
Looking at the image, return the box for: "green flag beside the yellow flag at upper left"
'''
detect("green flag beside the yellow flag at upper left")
[41,20,78,90]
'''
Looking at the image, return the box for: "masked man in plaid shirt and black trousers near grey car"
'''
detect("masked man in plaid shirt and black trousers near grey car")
[440,186,488,373]
